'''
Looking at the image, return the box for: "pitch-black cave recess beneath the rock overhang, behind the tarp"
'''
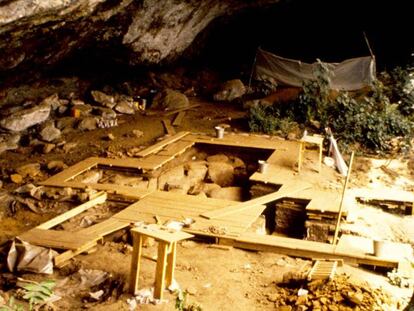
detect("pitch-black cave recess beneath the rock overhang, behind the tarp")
[6,0,413,88]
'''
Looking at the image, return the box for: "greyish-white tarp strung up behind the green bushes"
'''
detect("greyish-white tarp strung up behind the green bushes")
[254,48,375,91]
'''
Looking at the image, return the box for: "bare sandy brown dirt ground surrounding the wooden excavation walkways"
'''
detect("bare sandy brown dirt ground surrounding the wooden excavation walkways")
[0,100,414,310]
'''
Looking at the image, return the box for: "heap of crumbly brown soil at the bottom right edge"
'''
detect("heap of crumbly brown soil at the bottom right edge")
[267,275,401,311]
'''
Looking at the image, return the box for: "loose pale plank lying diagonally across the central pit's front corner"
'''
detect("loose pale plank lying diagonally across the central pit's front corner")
[200,184,309,219]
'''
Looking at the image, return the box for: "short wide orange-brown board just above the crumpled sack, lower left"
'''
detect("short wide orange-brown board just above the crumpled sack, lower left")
[19,228,99,250]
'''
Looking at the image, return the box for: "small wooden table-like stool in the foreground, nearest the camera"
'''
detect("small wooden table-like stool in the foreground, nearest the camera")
[129,225,193,299]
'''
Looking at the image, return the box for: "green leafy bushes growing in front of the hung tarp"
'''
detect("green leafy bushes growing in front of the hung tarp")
[249,61,414,152]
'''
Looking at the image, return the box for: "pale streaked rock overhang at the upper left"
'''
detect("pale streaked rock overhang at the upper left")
[0,0,279,73]
